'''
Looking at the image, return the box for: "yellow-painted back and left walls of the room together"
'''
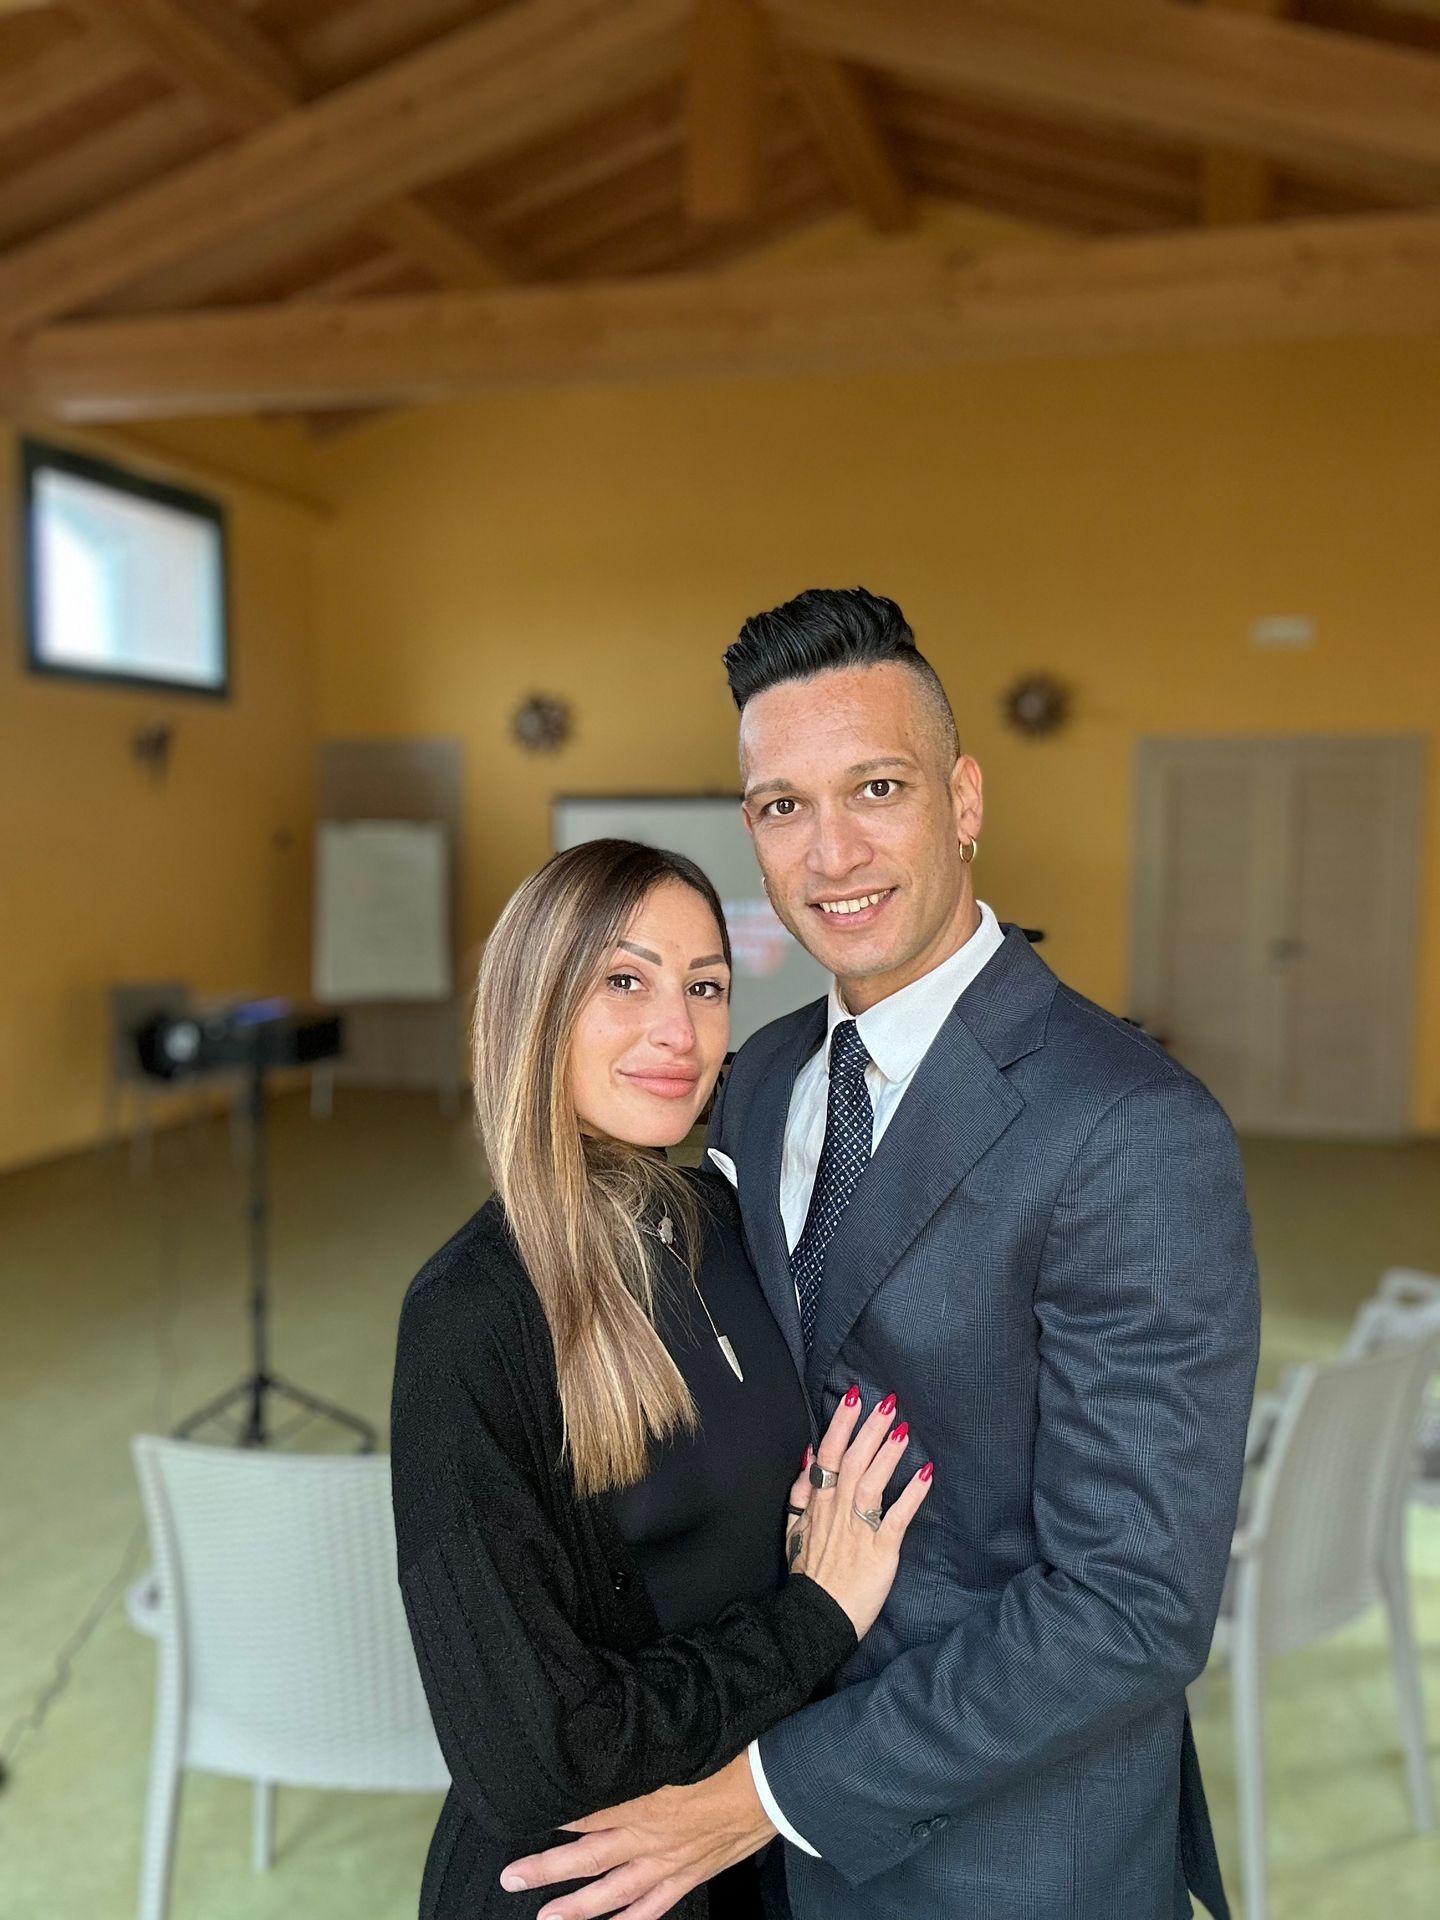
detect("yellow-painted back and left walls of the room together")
[0,332,1440,1165]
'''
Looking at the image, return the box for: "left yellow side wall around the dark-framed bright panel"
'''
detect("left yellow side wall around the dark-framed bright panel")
[0,420,315,1165]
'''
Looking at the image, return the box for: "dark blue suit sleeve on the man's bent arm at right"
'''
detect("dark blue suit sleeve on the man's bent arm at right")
[760,1073,1260,1884]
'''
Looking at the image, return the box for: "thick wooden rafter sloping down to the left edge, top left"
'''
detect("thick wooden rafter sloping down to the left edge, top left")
[0,0,685,328]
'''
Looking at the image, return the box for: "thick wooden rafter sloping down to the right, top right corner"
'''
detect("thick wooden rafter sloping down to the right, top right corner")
[758,0,1440,188]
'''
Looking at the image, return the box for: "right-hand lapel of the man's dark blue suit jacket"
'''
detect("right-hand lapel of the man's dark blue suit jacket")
[806,927,1056,1405]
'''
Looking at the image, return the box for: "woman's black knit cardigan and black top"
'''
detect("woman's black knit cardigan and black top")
[390,1175,854,1920]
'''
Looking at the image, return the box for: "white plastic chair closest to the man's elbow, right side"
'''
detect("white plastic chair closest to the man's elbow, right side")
[1215,1340,1440,1920]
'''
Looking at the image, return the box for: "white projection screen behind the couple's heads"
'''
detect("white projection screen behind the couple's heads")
[553,793,829,1046]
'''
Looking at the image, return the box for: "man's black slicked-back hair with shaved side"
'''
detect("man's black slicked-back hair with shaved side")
[726,588,960,760]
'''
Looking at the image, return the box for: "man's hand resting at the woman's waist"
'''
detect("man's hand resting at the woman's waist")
[499,1753,776,1920]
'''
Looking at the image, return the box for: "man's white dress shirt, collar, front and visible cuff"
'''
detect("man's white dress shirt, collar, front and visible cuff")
[737,900,1004,1859]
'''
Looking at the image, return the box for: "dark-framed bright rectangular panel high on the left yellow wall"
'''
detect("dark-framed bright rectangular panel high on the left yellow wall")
[19,438,230,699]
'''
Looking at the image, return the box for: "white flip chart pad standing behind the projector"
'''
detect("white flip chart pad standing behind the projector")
[313,820,451,1002]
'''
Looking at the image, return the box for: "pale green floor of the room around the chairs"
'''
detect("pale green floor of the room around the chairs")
[0,1091,1440,1920]
